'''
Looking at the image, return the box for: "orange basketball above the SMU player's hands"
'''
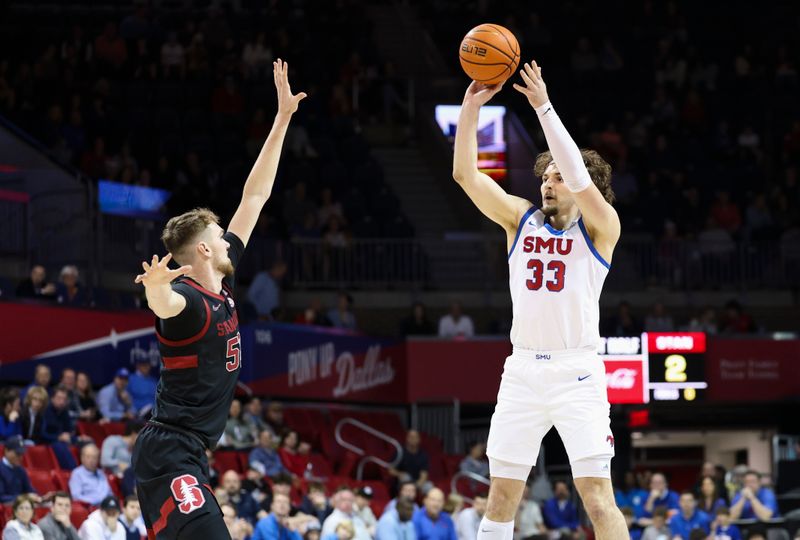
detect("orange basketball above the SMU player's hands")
[458,24,519,84]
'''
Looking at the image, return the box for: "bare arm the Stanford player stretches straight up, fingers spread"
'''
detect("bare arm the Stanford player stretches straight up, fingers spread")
[228,58,306,246]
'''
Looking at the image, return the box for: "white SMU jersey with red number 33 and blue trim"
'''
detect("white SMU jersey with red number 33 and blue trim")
[508,206,610,351]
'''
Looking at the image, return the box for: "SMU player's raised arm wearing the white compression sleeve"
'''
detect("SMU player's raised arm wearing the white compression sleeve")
[514,61,620,243]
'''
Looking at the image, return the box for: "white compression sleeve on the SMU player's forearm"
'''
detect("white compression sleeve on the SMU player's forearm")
[535,101,592,193]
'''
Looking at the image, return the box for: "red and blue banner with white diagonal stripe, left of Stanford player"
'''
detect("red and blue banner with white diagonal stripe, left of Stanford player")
[0,302,160,385]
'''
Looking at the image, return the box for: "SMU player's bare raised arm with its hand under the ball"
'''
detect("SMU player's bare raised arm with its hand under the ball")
[453,81,531,231]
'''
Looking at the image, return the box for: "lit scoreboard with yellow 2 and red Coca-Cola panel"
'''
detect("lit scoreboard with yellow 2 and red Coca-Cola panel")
[599,332,708,403]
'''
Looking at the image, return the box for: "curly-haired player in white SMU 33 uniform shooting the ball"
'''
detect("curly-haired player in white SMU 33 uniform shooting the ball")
[453,62,628,540]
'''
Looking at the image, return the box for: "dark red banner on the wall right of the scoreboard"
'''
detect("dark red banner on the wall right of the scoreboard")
[706,339,800,401]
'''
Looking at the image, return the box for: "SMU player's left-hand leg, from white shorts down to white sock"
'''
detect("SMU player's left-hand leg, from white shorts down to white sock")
[478,356,552,540]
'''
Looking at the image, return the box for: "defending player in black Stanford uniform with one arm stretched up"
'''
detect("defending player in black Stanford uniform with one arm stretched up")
[132,59,306,540]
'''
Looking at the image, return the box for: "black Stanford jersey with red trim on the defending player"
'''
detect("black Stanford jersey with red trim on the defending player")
[153,232,244,449]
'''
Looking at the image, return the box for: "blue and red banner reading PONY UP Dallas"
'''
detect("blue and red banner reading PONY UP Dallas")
[240,323,408,403]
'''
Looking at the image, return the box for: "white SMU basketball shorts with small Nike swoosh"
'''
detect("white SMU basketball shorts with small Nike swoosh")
[486,347,614,478]
